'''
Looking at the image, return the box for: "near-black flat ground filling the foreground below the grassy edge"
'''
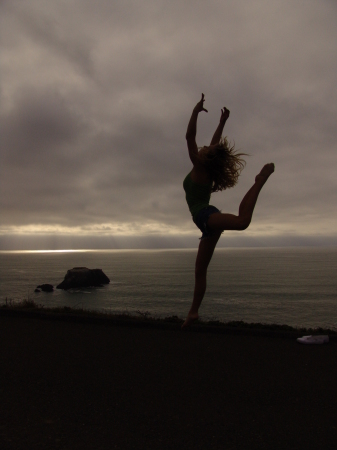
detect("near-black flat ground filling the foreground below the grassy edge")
[0,314,337,450]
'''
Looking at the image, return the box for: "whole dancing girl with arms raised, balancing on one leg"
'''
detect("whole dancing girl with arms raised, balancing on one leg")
[182,94,275,329]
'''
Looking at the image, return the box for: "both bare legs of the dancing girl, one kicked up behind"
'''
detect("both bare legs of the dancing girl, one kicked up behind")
[181,163,275,328]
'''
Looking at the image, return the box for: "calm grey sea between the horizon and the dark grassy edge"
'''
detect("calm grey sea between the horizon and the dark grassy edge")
[0,248,337,328]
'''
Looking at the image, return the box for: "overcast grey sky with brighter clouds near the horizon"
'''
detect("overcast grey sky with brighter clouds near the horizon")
[0,0,337,248]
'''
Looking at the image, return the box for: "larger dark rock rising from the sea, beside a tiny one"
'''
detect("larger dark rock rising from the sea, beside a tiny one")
[56,267,110,290]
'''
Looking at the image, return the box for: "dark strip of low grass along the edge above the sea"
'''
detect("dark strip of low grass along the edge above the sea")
[0,300,337,341]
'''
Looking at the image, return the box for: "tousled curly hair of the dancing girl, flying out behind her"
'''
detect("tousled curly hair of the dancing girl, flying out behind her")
[198,137,247,192]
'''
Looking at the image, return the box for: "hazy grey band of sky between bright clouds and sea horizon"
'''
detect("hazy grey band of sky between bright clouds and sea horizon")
[0,231,337,251]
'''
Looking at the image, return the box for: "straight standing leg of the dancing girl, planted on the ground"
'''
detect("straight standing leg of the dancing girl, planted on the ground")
[181,232,221,328]
